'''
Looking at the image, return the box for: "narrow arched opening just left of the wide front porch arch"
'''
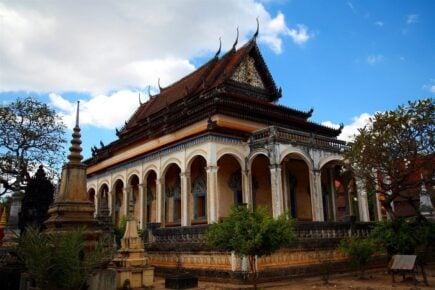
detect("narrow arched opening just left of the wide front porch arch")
[251,154,272,215]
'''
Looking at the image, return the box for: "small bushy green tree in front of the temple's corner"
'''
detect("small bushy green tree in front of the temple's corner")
[206,206,295,278]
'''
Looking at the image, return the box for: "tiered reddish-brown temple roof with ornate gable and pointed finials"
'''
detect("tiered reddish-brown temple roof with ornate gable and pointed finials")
[90,37,341,167]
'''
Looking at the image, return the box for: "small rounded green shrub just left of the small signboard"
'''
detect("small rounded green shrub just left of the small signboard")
[339,236,377,279]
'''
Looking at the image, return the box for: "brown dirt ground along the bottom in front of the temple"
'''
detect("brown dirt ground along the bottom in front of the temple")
[153,264,435,290]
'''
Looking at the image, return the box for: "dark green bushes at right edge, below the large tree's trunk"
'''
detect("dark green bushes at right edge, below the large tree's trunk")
[371,218,435,257]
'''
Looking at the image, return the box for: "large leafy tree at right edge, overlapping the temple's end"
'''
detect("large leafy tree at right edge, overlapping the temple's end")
[345,98,435,219]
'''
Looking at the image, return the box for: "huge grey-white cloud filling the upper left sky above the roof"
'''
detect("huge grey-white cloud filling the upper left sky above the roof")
[0,0,311,94]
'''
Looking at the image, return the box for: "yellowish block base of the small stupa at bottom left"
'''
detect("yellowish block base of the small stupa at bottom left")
[113,266,154,289]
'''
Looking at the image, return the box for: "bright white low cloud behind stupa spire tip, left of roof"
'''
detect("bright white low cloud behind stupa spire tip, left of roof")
[49,90,148,129]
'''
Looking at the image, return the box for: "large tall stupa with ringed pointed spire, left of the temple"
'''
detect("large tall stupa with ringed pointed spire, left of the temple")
[45,102,101,248]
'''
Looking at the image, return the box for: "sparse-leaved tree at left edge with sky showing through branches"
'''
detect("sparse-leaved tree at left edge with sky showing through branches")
[0,97,66,196]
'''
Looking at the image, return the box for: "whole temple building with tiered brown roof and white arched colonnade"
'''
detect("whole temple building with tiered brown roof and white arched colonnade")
[86,33,374,229]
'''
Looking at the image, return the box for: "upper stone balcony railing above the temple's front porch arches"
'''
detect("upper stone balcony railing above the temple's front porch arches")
[250,126,350,152]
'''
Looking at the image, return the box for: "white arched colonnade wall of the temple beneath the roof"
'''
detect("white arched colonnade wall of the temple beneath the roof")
[87,129,372,228]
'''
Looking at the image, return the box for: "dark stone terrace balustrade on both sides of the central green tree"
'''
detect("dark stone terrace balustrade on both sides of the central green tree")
[148,222,374,245]
